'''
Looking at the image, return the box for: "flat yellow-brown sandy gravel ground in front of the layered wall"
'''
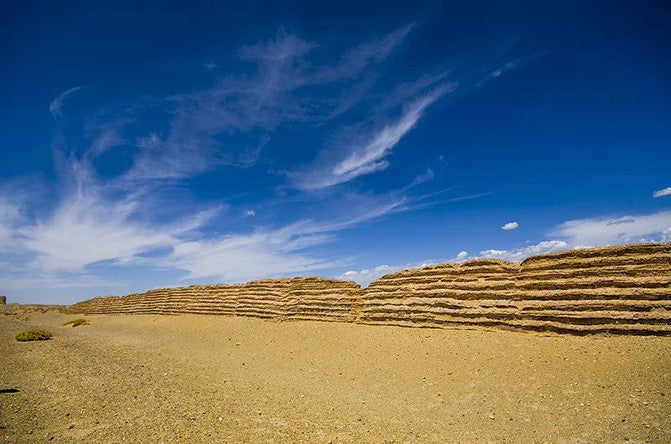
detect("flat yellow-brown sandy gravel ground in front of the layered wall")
[0,312,671,443]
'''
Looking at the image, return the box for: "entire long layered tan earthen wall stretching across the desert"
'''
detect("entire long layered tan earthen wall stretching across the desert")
[70,243,671,335]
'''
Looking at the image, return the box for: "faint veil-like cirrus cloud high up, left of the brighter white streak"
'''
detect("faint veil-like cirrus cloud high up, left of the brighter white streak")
[128,25,413,179]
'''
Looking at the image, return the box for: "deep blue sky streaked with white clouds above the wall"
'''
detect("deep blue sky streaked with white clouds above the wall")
[0,1,671,303]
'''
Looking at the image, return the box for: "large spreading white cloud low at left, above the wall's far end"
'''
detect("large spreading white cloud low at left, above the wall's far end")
[0,142,420,288]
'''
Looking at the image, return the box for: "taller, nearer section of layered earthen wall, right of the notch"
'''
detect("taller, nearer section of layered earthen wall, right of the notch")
[357,244,671,334]
